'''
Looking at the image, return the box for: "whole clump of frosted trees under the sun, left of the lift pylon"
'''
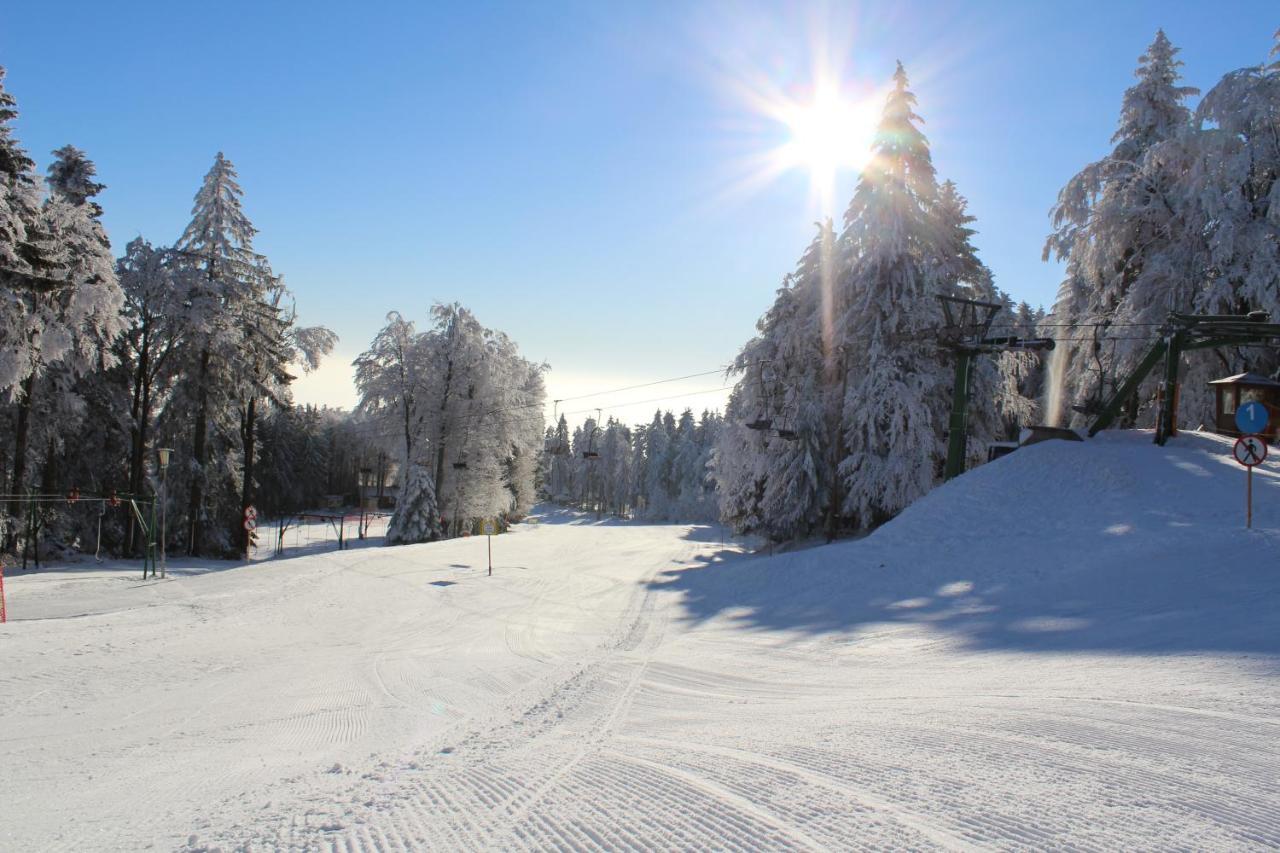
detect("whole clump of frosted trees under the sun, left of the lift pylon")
[712,64,1033,539]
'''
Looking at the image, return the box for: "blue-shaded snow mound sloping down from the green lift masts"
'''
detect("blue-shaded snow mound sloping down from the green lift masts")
[660,432,1280,653]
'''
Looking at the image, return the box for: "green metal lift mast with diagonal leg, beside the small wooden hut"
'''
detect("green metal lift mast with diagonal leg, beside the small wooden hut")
[1089,311,1280,444]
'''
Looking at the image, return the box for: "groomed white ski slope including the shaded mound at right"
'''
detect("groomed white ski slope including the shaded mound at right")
[0,433,1280,850]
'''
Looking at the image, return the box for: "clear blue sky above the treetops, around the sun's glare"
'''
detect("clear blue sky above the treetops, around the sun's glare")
[0,0,1280,420]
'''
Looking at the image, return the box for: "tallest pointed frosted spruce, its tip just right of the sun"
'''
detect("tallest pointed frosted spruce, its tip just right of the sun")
[840,63,952,529]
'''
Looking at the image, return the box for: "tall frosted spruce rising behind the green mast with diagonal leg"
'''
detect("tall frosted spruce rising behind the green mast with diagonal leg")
[1044,31,1198,423]
